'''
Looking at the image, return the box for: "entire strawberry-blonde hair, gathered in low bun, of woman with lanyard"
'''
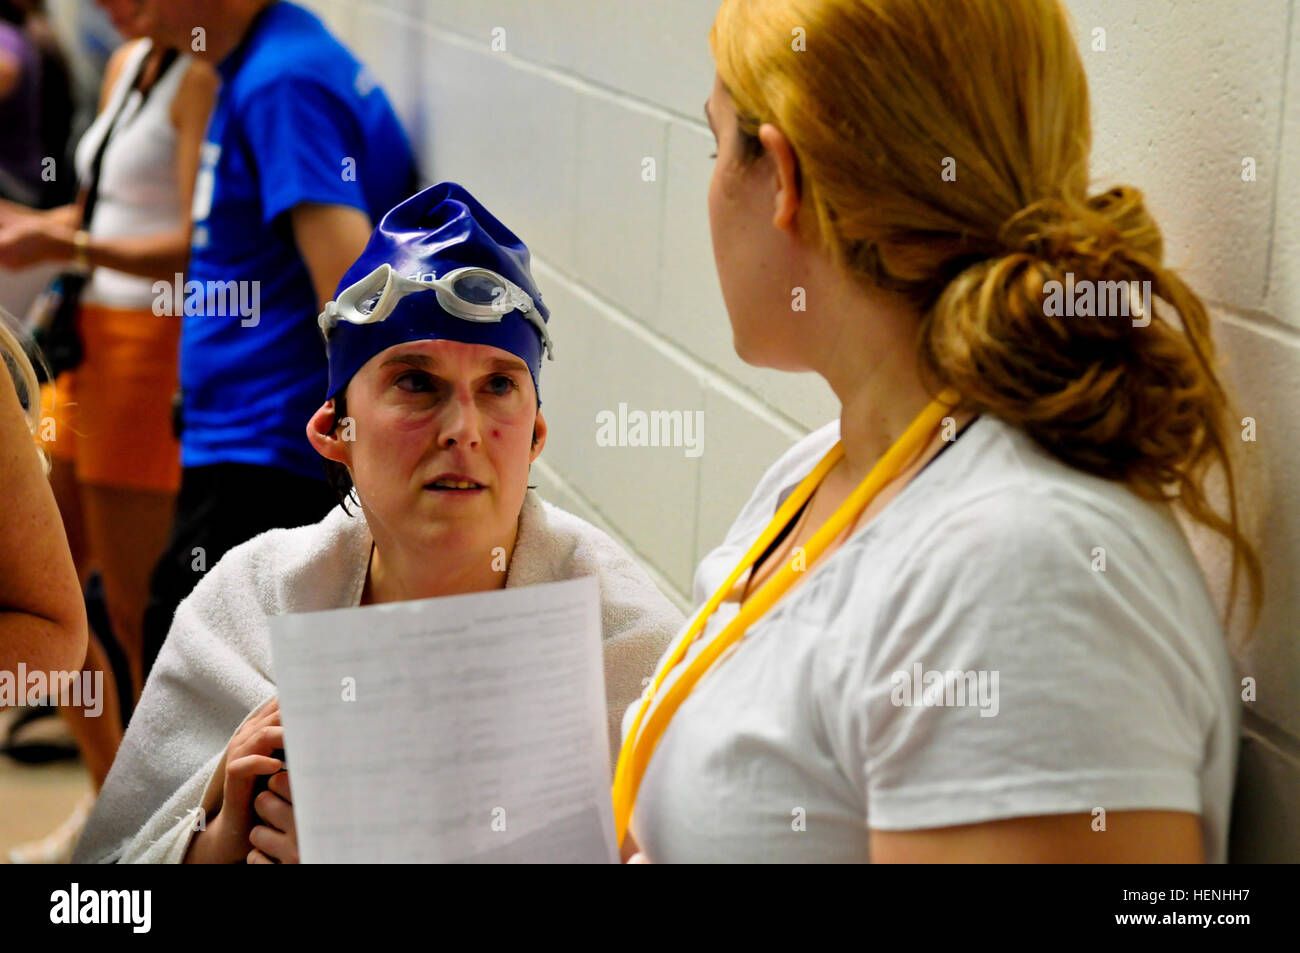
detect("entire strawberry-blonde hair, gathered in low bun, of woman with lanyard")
[710,0,1262,631]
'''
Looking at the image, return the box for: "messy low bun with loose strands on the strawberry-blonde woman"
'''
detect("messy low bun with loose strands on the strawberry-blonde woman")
[920,187,1262,631]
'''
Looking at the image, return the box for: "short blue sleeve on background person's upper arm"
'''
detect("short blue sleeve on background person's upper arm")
[241,75,368,229]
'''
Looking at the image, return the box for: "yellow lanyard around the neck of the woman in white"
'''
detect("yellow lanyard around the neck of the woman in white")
[612,389,959,846]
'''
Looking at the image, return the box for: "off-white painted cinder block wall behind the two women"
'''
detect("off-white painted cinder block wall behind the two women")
[299,0,1300,861]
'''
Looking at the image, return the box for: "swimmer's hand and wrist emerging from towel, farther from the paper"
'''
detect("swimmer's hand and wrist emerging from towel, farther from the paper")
[185,698,287,863]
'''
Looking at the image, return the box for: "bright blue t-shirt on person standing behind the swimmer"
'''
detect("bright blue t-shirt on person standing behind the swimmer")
[178,0,417,480]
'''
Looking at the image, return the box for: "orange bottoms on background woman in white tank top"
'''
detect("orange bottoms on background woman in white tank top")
[39,304,181,493]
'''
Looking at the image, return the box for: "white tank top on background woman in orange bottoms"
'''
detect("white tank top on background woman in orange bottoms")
[77,40,190,311]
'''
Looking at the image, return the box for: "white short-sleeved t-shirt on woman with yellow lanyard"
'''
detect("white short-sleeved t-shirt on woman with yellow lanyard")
[623,415,1240,862]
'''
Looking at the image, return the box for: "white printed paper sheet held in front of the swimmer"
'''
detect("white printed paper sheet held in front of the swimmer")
[270,579,618,863]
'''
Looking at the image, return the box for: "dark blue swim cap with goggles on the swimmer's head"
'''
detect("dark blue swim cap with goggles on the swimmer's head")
[319,182,553,406]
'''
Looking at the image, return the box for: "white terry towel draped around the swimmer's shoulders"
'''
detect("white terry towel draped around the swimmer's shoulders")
[73,490,684,863]
